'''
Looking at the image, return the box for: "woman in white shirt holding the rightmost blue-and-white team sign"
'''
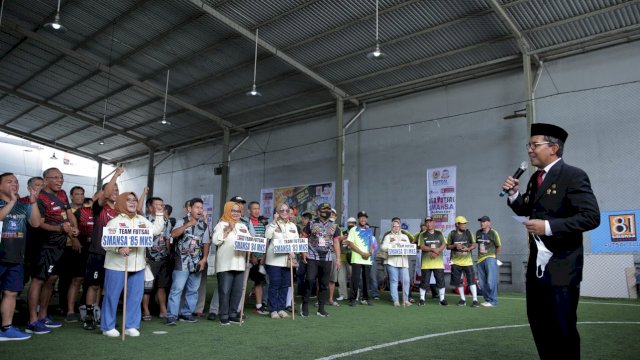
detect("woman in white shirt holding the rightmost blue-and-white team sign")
[380,220,412,306]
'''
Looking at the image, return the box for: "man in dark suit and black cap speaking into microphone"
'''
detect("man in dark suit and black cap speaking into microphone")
[502,124,600,359]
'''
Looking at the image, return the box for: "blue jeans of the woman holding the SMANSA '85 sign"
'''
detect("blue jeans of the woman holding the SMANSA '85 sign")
[100,269,144,331]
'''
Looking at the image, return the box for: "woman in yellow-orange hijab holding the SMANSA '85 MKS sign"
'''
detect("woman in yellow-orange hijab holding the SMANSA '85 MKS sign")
[100,192,165,337]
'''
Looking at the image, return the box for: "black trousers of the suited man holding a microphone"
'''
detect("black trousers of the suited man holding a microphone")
[526,279,580,360]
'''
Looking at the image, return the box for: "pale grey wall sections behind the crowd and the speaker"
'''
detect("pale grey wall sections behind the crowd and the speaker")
[122,42,640,290]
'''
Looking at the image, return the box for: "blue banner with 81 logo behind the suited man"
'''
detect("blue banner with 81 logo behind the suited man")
[589,210,640,254]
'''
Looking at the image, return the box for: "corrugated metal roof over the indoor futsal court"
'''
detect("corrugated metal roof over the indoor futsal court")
[0,0,640,161]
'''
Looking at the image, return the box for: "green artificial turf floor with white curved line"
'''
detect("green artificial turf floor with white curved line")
[0,277,640,360]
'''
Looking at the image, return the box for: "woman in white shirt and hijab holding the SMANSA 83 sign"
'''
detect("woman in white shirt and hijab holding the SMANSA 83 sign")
[265,204,299,319]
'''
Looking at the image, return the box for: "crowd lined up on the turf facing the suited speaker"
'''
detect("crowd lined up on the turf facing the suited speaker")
[0,168,500,340]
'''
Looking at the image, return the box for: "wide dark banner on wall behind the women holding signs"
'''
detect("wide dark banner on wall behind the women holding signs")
[260,180,349,224]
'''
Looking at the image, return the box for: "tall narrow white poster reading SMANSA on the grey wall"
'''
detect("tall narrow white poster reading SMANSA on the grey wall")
[427,166,456,272]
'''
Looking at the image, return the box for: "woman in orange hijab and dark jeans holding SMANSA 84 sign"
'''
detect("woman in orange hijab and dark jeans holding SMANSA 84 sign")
[213,201,251,325]
